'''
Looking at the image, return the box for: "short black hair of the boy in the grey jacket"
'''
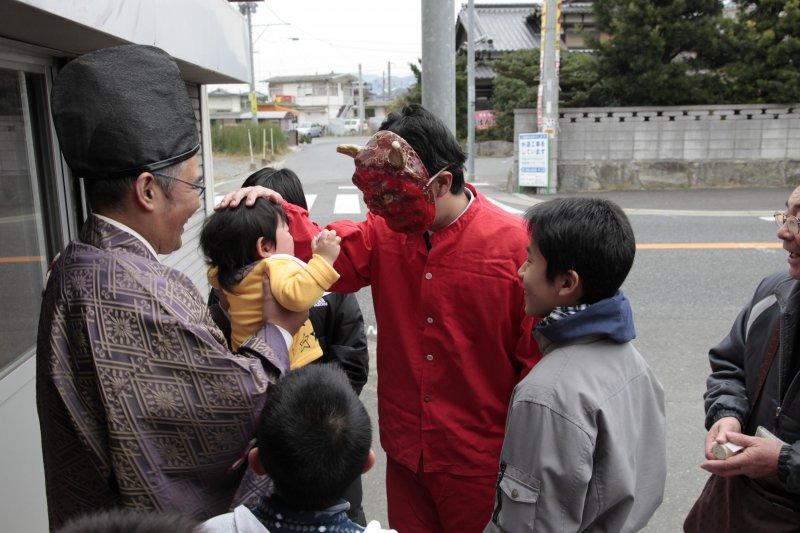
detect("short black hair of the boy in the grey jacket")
[525,198,636,304]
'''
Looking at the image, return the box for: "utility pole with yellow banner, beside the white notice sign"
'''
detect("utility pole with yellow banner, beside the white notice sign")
[536,0,561,193]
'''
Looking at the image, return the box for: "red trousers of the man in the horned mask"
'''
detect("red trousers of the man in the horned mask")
[386,457,497,533]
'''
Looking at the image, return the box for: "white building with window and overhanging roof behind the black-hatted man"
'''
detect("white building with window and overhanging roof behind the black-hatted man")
[0,0,250,531]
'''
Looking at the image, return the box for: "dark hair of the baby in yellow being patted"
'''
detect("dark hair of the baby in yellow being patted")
[200,198,288,289]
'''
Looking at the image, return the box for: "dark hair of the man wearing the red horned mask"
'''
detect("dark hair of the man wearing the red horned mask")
[379,104,467,194]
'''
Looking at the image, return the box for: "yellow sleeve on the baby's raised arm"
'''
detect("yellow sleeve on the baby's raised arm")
[268,254,339,311]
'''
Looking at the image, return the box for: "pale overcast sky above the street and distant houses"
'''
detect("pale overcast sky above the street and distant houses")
[219,0,531,90]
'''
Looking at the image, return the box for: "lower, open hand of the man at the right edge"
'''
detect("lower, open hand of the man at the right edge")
[700,432,783,478]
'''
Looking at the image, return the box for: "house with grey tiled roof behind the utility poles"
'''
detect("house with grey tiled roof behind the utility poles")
[456,1,596,111]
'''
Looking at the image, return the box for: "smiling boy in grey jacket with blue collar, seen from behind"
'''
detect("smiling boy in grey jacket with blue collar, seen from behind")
[485,198,667,533]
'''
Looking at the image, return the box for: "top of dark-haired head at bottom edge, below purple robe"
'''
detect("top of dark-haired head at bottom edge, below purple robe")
[58,509,199,533]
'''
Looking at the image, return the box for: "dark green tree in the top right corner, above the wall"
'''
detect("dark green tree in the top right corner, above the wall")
[722,0,800,103]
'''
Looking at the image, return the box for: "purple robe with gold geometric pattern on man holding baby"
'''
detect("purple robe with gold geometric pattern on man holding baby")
[36,217,289,528]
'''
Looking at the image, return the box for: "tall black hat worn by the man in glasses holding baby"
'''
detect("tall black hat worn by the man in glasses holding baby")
[51,44,200,178]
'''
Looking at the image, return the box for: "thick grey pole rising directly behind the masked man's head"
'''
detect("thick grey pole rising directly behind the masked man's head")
[422,0,456,134]
